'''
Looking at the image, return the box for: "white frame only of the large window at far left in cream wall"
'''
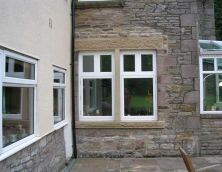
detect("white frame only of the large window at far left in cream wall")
[0,49,37,154]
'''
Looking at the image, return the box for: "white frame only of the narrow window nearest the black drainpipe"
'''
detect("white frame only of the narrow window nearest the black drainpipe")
[53,66,66,128]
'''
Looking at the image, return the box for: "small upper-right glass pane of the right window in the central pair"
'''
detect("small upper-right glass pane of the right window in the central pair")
[141,54,153,71]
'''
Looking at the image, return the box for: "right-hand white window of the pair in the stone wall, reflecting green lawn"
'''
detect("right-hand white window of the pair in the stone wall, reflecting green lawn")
[120,50,157,121]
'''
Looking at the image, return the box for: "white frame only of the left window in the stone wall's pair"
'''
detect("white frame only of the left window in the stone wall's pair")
[79,51,114,121]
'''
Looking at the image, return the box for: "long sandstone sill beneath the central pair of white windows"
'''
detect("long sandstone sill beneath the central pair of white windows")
[76,121,165,128]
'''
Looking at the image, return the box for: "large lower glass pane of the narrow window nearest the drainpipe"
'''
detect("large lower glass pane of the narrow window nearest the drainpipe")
[53,88,65,124]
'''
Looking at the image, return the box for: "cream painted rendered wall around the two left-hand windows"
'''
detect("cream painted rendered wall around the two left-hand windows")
[0,0,72,157]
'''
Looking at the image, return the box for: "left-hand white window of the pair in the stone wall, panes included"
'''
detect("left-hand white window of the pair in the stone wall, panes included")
[79,51,114,121]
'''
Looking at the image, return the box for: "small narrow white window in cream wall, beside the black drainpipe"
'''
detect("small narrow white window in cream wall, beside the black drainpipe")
[53,67,66,125]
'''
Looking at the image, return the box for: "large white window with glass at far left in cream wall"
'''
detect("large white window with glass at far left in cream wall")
[0,50,37,153]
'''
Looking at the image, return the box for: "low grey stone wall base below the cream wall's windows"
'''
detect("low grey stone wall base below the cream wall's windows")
[0,128,66,172]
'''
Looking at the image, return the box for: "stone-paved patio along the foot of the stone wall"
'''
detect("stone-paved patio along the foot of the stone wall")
[66,157,222,172]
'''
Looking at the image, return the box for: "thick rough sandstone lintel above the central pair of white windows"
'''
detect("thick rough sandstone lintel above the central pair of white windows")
[75,37,163,51]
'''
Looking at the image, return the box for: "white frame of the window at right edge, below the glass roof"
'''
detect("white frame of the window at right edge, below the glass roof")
[199,55,222,114]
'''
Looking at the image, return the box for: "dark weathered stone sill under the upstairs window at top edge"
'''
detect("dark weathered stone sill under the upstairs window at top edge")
[75,0,124,8]
